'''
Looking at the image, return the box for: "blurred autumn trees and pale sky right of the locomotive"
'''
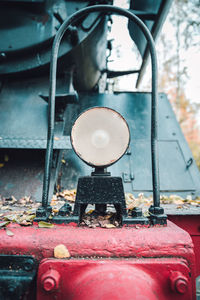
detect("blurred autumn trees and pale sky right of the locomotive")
[158,0,200,167]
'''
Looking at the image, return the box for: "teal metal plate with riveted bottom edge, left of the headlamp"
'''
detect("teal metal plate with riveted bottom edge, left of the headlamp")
[0,78,71,149]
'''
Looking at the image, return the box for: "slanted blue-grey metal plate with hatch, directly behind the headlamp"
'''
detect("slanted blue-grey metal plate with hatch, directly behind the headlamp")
[62,93,200,197]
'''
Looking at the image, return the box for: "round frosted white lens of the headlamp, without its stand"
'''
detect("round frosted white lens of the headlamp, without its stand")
[71,107,130,168]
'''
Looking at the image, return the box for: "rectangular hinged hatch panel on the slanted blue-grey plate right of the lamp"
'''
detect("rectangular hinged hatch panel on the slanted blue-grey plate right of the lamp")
[131,140,194,193]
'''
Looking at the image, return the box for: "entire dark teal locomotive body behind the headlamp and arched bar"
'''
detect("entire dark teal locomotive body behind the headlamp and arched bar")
[0,1,200,201]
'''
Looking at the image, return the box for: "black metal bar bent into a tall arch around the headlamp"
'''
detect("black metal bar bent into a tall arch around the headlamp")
[42,5,160,212]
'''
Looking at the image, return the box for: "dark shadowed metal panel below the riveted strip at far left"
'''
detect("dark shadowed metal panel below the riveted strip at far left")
[0,149,58,202]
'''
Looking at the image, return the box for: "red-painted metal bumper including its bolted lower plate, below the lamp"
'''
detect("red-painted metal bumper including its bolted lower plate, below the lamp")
[0,222,195,300]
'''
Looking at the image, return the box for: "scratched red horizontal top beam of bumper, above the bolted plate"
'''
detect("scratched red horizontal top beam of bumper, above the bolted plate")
[0,221,195,300]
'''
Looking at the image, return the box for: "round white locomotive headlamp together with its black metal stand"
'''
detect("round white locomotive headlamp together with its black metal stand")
[62,107,148,224]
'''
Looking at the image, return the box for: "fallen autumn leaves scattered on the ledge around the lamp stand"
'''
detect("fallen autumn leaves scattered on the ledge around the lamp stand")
[0,189,200,229]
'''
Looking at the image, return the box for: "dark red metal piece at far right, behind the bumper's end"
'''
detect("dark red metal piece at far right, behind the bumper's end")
[169,215,200,276]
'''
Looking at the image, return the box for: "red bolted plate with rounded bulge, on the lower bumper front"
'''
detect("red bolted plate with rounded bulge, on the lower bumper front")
[37,258,193,300]
